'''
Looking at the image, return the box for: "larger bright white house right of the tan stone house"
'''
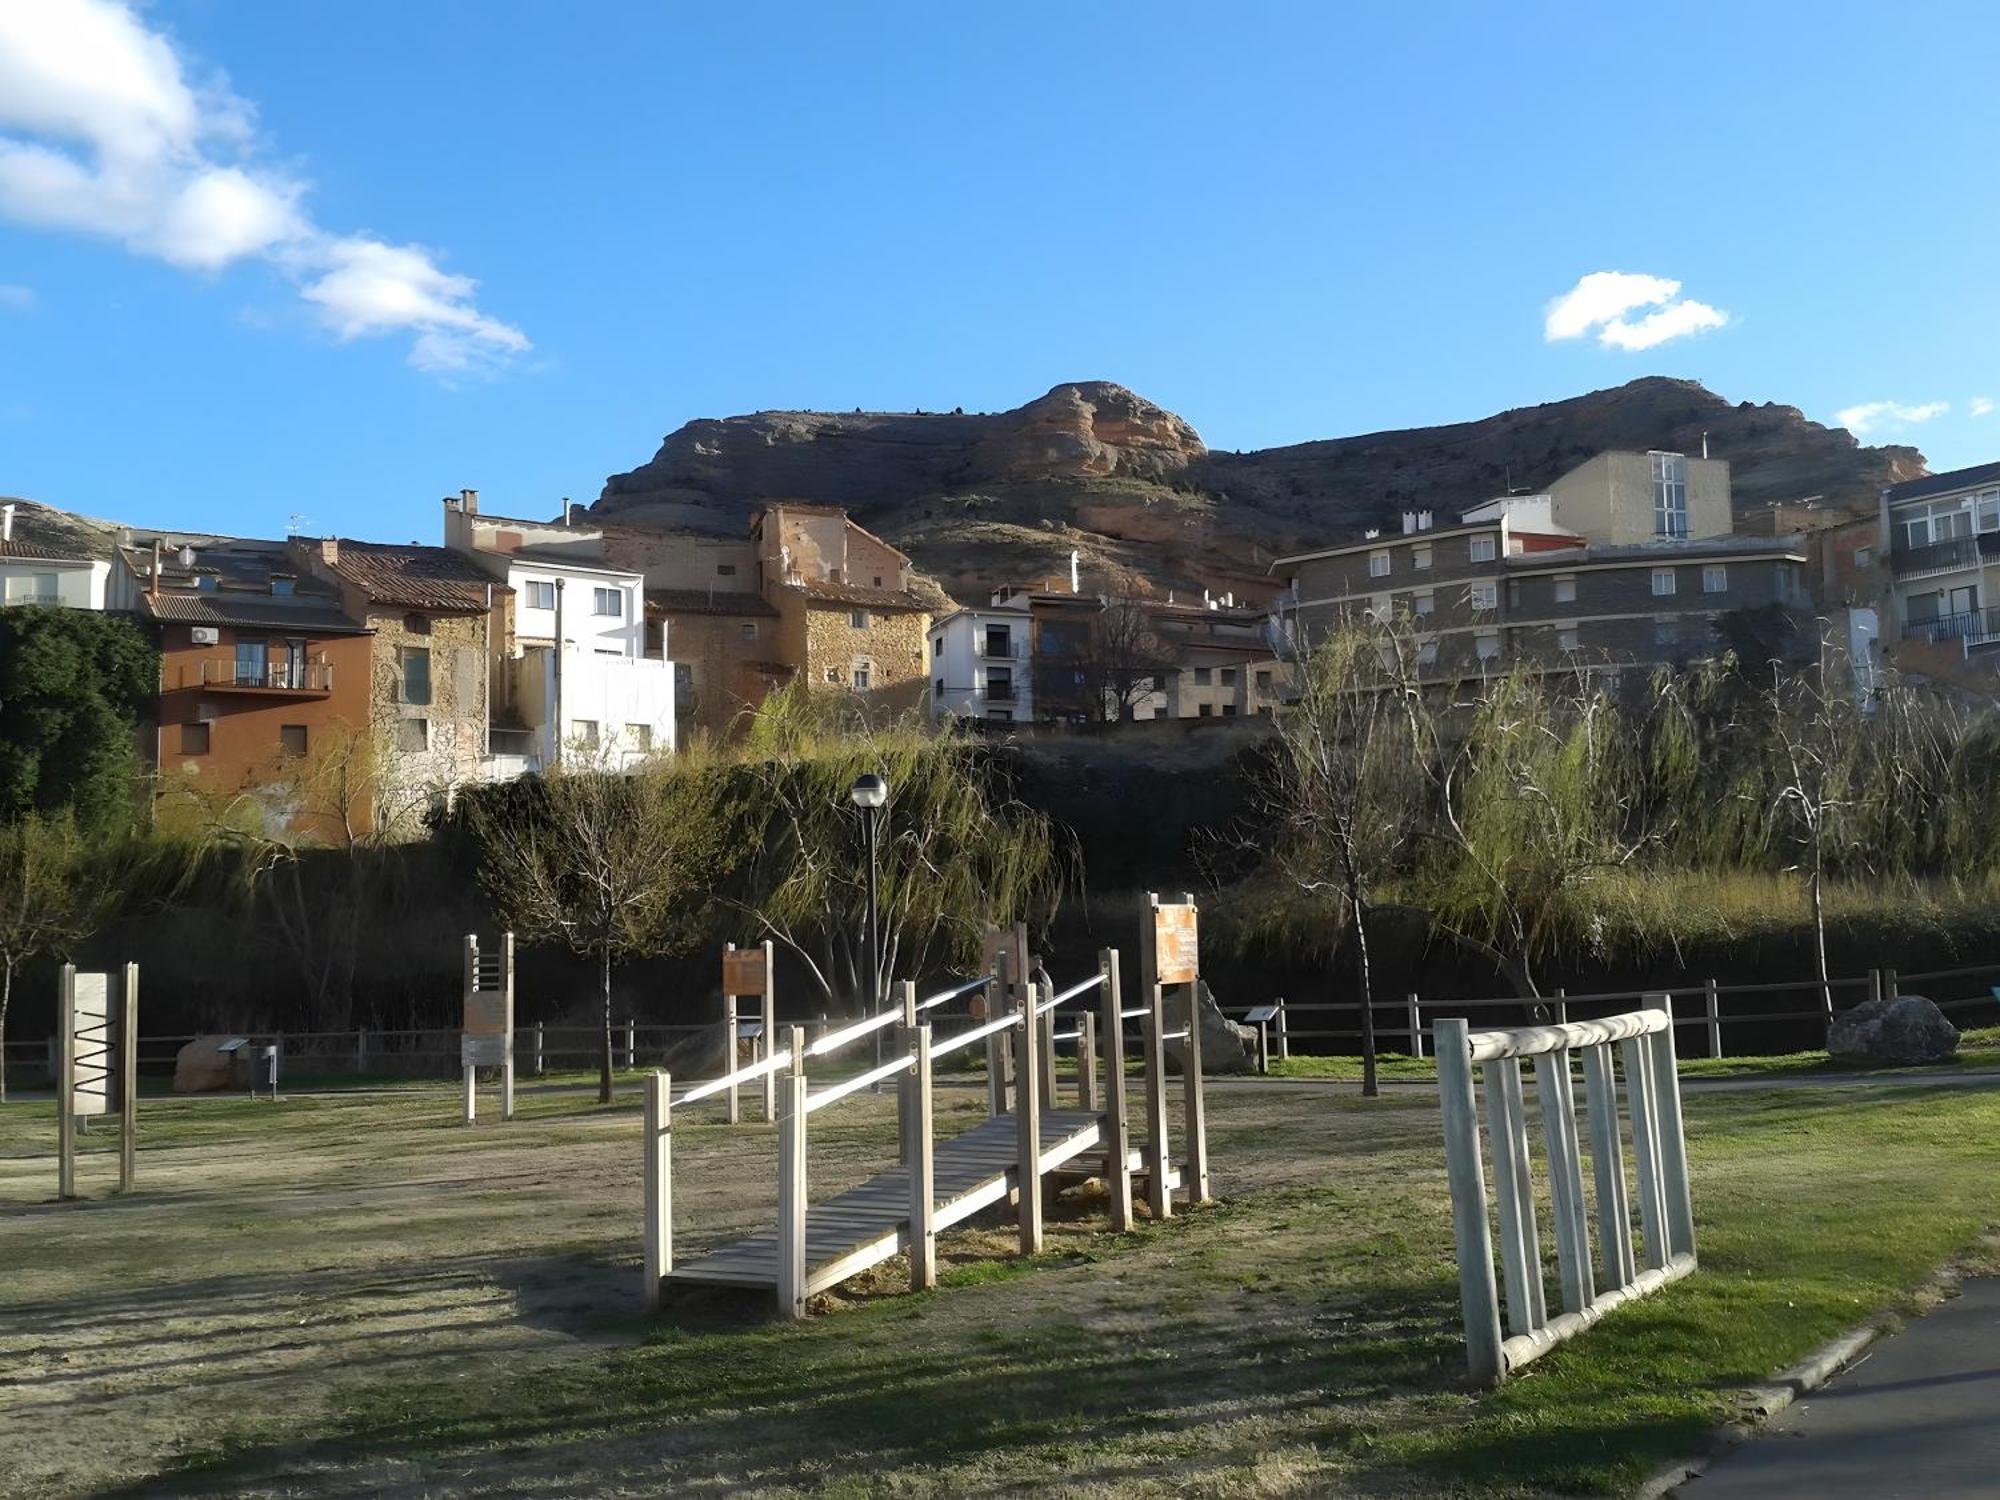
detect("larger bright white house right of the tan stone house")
[444,490,676,780]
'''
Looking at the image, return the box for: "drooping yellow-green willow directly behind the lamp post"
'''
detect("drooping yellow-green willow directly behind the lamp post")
[722,688,1066,1012]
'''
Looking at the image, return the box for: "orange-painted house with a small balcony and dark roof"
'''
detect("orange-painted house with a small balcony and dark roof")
[112,534,374,842]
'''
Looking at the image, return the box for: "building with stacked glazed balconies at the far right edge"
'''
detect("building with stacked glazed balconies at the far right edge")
[1880,464,2000,660]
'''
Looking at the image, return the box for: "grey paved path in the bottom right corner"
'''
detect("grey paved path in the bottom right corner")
[1674,1278,2000,1500]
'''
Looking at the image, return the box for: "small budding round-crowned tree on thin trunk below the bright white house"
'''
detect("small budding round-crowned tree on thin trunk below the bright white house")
[470,762,720,1104]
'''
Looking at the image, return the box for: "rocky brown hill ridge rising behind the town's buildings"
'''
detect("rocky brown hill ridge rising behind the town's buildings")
[592,376,1926,600]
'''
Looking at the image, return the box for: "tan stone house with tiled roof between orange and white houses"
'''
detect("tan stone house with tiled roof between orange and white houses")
[292,536,512,832]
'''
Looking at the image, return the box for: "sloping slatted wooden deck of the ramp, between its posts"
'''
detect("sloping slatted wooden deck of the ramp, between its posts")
[668,1110,1104,1296]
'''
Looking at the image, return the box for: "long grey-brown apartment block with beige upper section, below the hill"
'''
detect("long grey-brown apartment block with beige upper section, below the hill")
[1272,452,1810,680]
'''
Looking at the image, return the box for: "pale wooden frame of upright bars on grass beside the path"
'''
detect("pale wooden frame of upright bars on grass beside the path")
[1434,994,1696,1384]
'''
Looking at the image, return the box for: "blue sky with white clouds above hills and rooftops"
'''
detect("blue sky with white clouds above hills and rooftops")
[0,0,2000,540]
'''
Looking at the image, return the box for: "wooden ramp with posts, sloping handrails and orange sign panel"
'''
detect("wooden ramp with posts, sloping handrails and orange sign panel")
[644,896,1208,1318]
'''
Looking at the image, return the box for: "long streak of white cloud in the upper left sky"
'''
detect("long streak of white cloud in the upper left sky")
[0,0,528,372]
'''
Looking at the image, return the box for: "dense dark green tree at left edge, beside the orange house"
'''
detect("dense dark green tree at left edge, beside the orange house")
[0,608,160,826]
